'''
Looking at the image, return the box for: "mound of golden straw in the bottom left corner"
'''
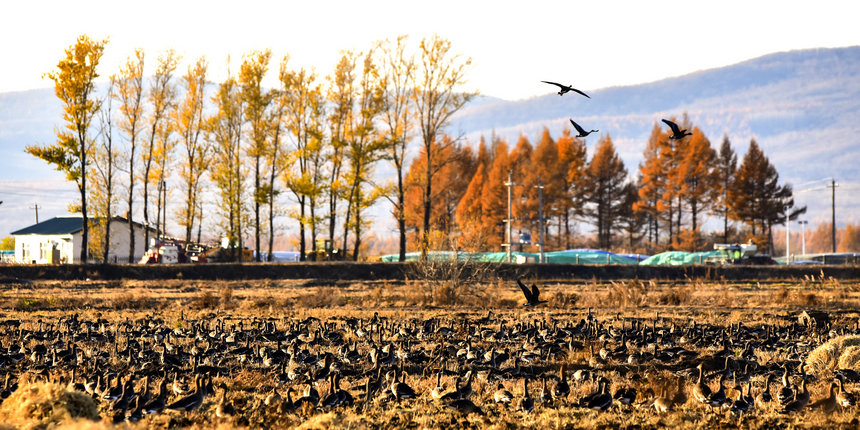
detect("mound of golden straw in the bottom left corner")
[0,382,100,429]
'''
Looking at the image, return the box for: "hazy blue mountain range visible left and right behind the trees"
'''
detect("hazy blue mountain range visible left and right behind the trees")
[0,46,860,244]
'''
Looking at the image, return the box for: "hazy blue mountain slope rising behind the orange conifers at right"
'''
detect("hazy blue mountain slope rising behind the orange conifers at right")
[451,46,860,228]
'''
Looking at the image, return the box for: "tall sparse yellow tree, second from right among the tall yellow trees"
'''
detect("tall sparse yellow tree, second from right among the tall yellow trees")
[377,36,416,261]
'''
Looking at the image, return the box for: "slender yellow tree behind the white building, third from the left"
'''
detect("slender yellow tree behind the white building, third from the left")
[114,49,147,262]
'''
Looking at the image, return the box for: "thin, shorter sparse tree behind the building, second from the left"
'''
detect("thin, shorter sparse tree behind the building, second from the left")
[89,76,118,263]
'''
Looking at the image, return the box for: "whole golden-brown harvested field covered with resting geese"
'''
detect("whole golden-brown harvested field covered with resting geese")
[0,276,860,428]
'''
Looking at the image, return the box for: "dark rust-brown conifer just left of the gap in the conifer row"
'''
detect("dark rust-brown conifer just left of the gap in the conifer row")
[584,135,628,249]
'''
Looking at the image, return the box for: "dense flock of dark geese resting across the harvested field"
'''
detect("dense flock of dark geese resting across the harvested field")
[0,281,860,424]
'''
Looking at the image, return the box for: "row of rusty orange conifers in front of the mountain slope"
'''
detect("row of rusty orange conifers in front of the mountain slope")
[406,118,805,252]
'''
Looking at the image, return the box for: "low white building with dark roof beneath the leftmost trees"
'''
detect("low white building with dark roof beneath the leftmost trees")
[11,216,154,264]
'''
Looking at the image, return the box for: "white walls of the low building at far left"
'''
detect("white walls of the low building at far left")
[15,221,146,264]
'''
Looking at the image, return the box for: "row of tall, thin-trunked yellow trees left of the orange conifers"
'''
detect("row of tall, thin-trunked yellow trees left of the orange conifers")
[27,35,474,260]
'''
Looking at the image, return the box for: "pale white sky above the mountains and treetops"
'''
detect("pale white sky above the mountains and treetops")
[5,0,860,99]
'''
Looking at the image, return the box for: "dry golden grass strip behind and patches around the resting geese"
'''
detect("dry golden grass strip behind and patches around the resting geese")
[0,278,860,429]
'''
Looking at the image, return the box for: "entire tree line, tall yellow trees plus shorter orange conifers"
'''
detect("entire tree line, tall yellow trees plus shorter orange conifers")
[27,36,805,259]
